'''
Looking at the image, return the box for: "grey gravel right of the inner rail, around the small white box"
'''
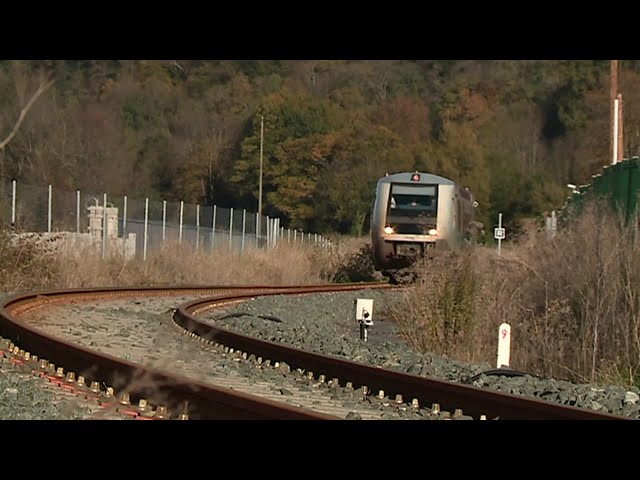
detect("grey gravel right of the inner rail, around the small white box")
[203,290,640,419]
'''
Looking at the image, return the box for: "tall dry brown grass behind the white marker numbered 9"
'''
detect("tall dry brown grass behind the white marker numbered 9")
[390,201,640,385]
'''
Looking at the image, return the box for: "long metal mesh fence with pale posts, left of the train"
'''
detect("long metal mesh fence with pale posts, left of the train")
[0,181,328,259]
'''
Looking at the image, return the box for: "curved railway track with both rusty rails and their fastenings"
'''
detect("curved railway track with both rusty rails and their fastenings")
[0,284,625,420]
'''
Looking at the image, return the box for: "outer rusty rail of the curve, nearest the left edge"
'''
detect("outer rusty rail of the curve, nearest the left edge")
[0,284,382,420]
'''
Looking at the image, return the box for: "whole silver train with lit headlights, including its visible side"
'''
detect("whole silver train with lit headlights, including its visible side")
[371,172,481,272]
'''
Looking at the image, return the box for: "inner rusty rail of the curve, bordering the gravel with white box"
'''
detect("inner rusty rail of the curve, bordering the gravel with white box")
[174,293,628,420]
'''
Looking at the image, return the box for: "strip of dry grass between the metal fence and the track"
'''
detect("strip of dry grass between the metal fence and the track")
[0,230,370,291]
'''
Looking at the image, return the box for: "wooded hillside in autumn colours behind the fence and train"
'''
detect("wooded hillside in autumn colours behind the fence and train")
[0,60,640,234]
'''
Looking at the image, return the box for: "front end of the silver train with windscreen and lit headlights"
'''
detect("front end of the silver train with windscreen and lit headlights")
[371,173,455,270]
